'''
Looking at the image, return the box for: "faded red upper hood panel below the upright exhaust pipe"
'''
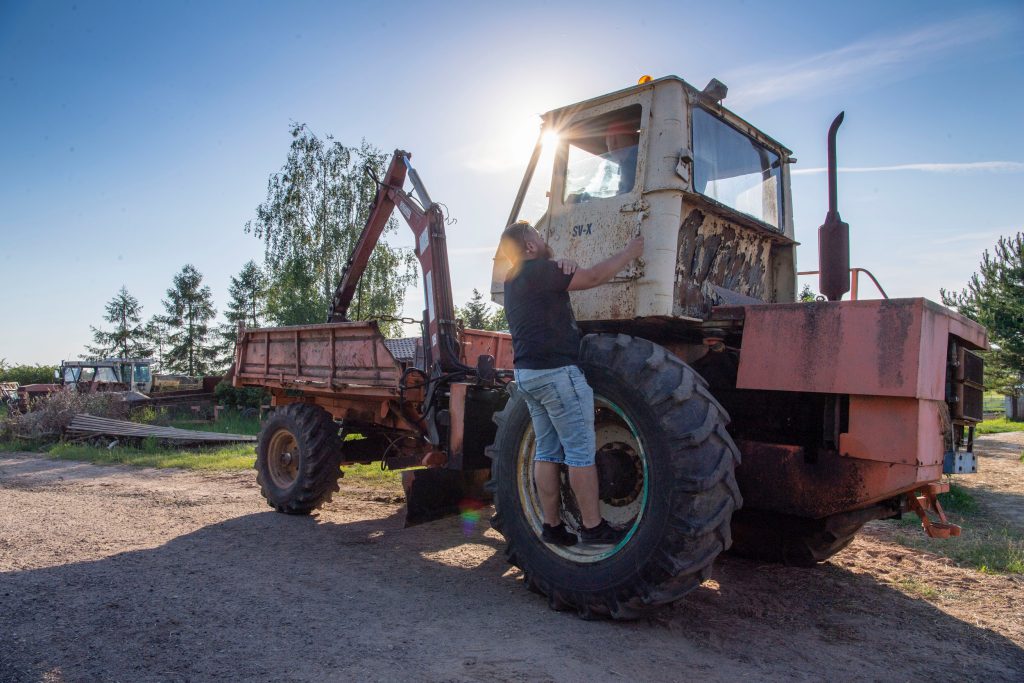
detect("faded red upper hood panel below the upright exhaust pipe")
[737,299,987,400]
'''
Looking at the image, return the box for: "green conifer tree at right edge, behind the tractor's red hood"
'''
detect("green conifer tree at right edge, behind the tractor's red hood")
[940,232,1024,416]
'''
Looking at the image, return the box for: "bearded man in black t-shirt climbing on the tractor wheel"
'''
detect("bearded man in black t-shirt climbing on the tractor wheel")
[501,222,643,546]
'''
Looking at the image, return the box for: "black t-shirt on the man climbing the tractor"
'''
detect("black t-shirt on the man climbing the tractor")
[505,259,580,370]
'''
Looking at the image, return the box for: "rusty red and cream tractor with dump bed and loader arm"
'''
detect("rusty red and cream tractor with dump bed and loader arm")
[233,77,987,618]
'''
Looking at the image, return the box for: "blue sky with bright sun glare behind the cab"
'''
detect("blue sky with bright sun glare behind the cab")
[0,0,1024,365]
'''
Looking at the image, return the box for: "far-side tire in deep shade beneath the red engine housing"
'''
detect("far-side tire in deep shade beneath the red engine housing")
[730,510,865,567]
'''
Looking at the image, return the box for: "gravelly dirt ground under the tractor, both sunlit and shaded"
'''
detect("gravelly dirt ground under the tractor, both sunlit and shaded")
[0,435,1024,682]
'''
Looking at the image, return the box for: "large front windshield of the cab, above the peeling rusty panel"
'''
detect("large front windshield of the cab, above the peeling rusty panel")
[693,108,782,228]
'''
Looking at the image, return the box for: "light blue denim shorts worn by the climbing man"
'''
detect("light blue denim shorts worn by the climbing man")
[515,366,596,467]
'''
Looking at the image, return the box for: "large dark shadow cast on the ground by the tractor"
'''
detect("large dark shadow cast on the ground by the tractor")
[0,501,1024,681]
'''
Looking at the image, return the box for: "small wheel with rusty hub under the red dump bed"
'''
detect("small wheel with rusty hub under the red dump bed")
[255,403,342,515]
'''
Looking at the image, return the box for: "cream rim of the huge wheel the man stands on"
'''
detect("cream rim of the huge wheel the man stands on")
[516,392,648,563]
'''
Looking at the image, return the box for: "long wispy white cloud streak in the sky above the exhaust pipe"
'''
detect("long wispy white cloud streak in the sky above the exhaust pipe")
[725,13,1014,109]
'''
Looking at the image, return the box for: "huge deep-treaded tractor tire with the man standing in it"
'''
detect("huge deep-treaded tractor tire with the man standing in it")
[488,335,741,620]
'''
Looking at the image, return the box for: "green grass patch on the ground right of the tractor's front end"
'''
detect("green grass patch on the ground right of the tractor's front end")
[893,484,1024,573]
